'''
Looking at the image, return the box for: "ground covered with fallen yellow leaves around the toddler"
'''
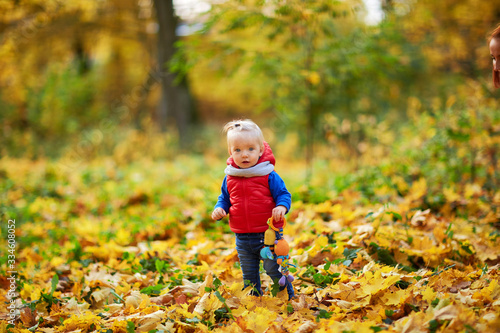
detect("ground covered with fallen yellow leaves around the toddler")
[0,157,500,333]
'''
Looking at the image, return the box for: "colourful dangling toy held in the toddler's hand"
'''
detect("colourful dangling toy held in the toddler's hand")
[260,217,296,286]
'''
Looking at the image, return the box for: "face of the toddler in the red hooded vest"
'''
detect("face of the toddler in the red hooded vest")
[228,132,263,169]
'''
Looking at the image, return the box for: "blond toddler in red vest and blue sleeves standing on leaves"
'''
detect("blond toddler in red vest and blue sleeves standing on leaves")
[212,120,294,299]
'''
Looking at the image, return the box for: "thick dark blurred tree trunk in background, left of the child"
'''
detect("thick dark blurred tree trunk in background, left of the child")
[154,0,194,146]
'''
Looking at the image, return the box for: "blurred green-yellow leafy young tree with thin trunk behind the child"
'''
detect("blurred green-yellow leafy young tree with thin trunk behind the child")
[178,0,422,176]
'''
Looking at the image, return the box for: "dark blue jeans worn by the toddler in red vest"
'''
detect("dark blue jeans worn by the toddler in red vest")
[236,232,295,299]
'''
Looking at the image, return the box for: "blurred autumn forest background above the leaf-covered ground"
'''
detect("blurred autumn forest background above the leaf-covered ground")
[0,0,500,193]
